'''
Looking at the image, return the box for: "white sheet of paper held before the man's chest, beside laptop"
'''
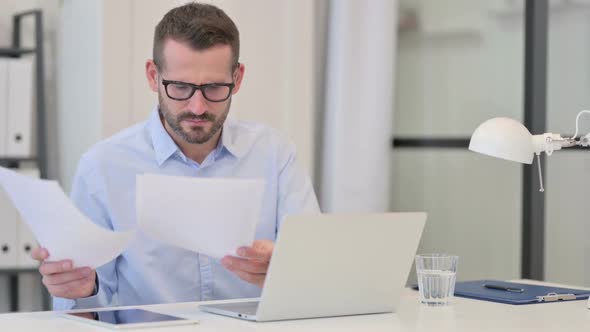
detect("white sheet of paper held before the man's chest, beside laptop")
[137,174,264,258]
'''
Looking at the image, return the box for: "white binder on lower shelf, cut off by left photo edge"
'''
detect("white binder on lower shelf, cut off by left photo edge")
[0,188,17,269]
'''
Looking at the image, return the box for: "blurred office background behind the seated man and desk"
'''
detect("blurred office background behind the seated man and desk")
[0,0,590,312]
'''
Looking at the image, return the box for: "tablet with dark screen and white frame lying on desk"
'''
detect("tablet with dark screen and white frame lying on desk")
[60,309,199,329]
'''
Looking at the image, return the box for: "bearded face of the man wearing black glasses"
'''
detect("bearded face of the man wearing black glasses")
[154,40,243,144]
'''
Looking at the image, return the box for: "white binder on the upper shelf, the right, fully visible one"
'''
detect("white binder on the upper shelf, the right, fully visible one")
[5,57,34,158]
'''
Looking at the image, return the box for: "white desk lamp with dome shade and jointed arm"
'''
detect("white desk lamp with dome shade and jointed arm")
[469,111,590,192]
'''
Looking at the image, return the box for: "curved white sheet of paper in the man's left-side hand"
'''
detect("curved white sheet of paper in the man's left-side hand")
[0,167,135,268]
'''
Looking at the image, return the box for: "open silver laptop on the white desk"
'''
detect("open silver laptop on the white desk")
[200,212,426,322]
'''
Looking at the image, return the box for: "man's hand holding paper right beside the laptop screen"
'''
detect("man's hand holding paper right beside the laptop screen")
[221,240,274,287]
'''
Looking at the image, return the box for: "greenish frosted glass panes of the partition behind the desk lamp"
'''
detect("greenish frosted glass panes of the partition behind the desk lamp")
[392,0,590,286]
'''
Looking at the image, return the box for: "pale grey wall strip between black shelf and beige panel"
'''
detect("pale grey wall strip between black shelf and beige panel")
[57,0,103,196]
